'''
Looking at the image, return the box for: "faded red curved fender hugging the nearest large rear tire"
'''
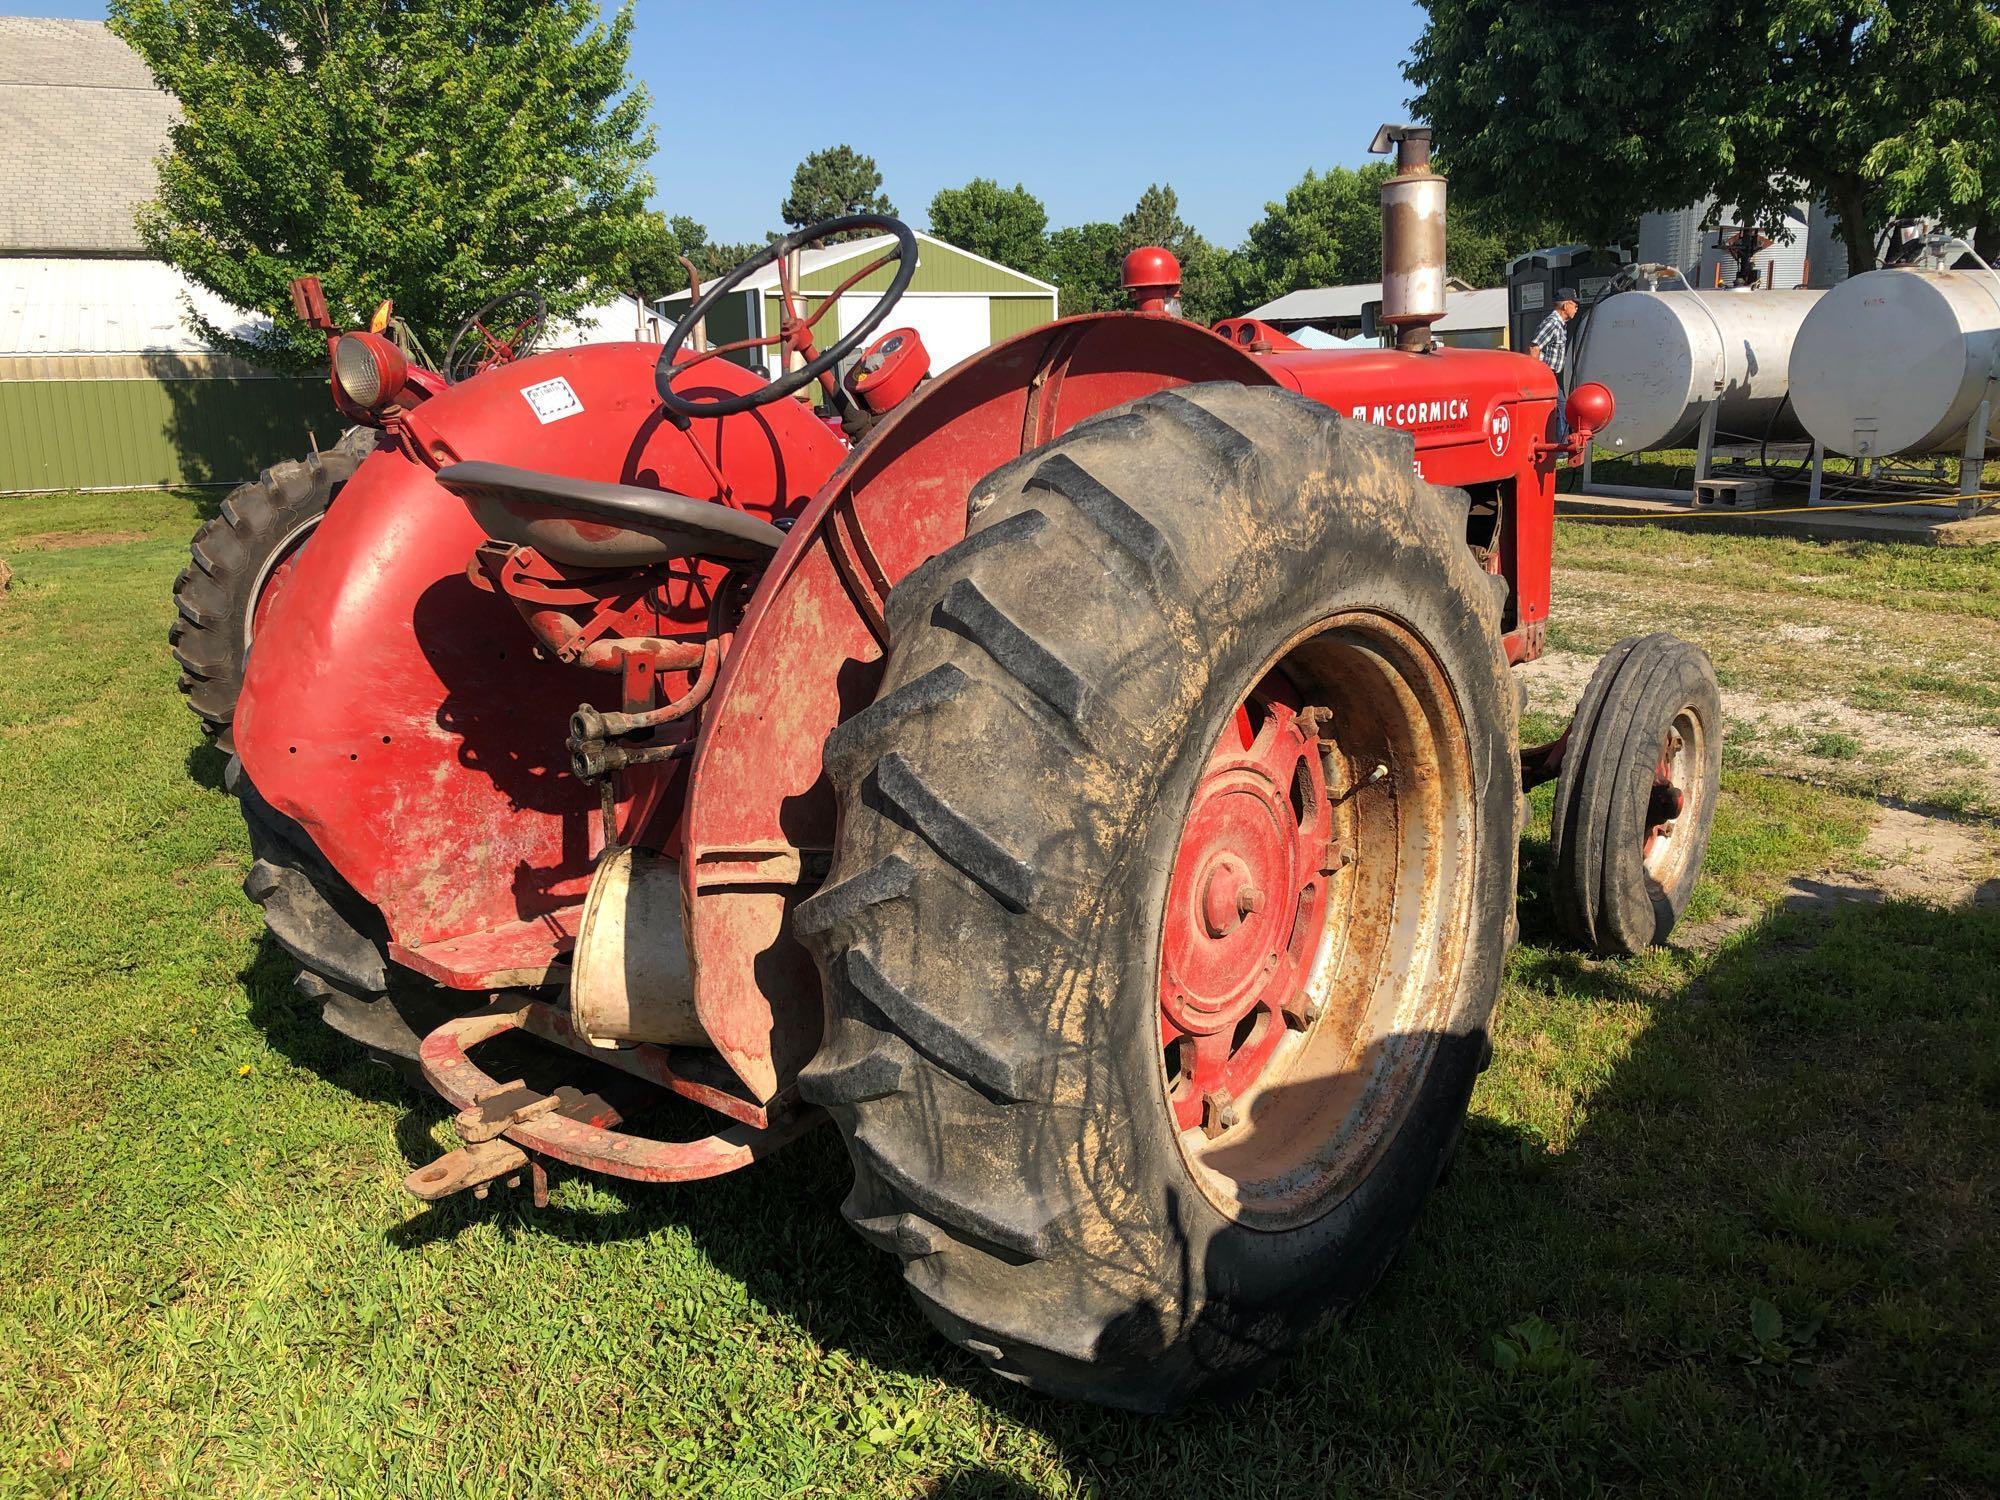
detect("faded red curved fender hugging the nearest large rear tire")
[682,314,1272,1098]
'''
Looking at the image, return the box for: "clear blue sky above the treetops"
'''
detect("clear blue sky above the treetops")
[0,0,1422,244]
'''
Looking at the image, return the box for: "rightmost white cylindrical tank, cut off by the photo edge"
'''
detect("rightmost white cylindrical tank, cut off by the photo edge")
[1792,266,2000,458]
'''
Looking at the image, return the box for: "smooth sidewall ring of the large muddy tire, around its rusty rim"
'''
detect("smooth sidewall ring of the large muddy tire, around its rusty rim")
[1048,450,1518,1384]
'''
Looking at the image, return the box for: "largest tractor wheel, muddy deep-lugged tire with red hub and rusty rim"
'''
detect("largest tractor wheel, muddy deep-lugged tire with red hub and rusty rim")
[798,384,1518,1410]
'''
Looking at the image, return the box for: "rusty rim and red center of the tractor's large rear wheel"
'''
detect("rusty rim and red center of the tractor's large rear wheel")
[1158,612,1476,1230]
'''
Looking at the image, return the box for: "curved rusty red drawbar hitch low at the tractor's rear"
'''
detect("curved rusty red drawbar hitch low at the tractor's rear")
[402,996,824,1208]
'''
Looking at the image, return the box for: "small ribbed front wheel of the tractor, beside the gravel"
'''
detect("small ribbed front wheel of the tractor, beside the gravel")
[1550,634,1722,956]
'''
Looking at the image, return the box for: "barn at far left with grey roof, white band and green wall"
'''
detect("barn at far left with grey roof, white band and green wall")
[0,16,342,494]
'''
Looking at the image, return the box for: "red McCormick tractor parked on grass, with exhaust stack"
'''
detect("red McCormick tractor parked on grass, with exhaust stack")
[215,130,1720,1410]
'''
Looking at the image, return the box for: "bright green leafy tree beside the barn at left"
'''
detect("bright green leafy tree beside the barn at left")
[110,0,652,368]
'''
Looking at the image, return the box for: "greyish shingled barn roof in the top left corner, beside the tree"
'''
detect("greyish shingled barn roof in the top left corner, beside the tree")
[0,16,174,256]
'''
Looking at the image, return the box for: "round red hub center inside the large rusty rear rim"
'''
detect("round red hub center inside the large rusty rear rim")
[1160,676,1332,1136]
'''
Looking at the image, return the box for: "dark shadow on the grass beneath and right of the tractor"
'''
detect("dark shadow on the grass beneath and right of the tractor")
[238,888,2000,1496]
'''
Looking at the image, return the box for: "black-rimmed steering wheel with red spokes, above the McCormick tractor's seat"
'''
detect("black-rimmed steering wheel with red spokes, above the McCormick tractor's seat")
[652,214,916,426]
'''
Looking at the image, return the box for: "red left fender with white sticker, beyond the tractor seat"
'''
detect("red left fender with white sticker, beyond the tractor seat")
[236,344,844,988]
